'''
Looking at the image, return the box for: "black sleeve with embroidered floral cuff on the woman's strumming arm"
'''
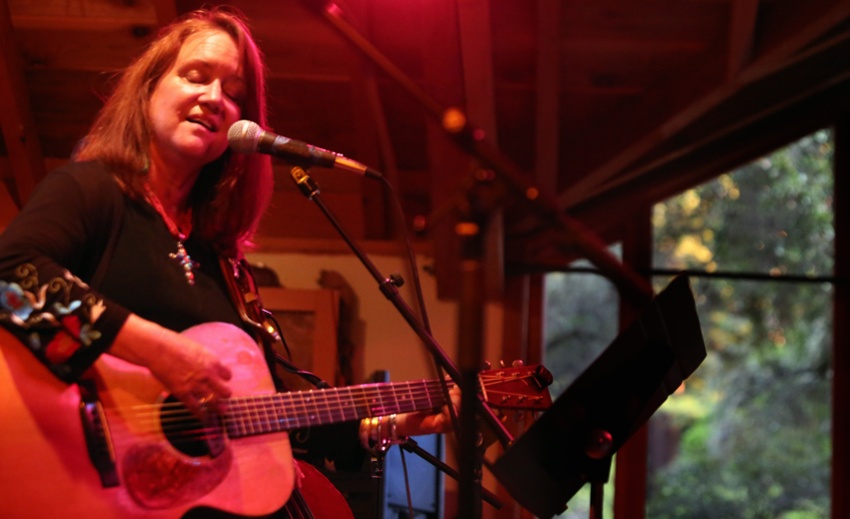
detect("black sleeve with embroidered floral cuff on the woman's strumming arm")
[0,162,128,382]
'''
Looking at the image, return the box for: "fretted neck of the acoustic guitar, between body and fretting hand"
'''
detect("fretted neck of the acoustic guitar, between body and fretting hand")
[222,380,446,438]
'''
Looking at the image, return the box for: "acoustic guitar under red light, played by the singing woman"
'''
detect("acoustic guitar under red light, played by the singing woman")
[0,323,551,519]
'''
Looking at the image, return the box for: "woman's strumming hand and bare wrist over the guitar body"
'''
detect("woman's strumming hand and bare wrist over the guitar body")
[109,314,231,414]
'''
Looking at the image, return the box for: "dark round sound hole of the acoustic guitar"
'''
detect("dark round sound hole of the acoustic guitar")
[160,396,224,457]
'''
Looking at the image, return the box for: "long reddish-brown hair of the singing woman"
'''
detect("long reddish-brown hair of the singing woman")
[73,7,273,256]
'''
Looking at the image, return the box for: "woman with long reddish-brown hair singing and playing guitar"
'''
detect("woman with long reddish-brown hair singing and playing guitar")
[0,9,447,519]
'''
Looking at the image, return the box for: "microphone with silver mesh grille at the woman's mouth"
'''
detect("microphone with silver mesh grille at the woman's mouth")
[227,120,381,178]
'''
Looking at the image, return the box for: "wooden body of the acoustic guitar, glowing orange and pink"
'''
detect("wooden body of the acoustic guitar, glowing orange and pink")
[0,323,294,518]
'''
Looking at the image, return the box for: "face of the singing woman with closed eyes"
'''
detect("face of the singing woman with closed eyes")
[148,30,246,171]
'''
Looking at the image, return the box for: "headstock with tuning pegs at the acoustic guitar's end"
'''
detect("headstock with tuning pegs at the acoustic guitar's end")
[478,365,552,411]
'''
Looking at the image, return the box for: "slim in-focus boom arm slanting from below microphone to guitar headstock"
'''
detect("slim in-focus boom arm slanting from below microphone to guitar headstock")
[290,166,513,447]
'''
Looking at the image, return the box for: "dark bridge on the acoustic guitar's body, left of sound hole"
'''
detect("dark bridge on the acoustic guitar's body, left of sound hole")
[78,381,118,488]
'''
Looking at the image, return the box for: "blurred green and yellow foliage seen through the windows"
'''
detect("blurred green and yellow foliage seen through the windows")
[546,131,834,519]
